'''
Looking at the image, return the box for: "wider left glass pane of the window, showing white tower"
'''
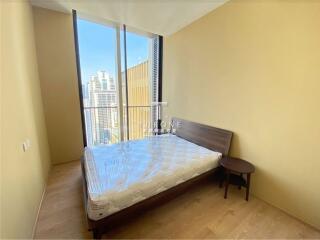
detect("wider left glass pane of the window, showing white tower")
[77,19,120,146]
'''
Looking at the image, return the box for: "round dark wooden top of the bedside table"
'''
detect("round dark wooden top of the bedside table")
[220,157,255,173]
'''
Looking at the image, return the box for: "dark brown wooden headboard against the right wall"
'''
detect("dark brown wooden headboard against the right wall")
[171,118,232,156]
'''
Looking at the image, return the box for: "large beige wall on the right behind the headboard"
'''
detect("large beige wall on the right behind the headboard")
[164,1,320,228]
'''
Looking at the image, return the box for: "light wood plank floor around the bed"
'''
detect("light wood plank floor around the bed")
[35,162,320,239]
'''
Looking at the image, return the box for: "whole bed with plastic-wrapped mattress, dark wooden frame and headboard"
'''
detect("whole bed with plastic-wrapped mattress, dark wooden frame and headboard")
[81,118,232,239]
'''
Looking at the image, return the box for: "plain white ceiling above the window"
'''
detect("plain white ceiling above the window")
[31,0,228,36]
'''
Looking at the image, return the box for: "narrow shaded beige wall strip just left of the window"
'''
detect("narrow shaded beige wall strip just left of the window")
[33,7,83,164]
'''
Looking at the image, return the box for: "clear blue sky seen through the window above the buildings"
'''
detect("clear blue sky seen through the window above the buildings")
[78,19,150,83]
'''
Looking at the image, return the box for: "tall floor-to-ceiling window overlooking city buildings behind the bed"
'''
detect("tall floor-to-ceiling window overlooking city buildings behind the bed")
[75,11,161,146]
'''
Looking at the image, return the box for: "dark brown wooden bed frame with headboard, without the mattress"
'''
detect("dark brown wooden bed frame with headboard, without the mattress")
[81,118,232,239]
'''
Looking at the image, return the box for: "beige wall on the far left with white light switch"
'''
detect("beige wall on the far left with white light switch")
[0,0,50,238]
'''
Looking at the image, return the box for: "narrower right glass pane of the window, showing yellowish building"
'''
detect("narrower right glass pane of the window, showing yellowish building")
[126,32,152,140]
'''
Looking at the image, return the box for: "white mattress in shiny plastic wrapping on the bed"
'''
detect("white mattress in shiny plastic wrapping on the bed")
[85,134,221,220]
